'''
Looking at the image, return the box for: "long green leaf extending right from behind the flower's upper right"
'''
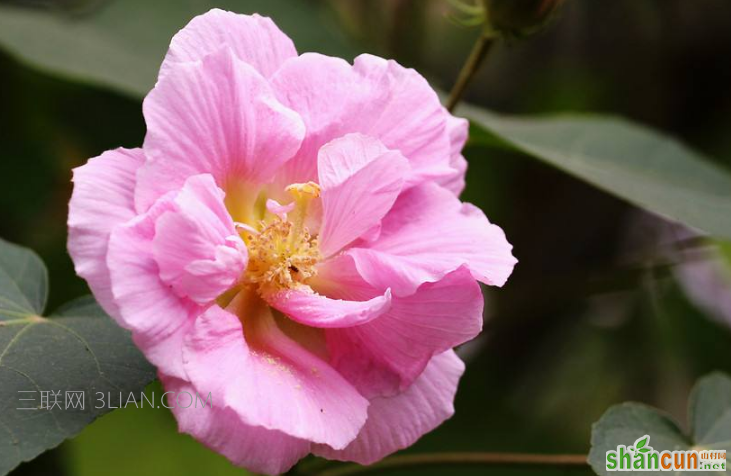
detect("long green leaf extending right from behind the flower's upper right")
[461,106,731,242]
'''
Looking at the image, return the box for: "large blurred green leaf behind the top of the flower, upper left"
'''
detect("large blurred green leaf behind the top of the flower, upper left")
[0,0,355,97]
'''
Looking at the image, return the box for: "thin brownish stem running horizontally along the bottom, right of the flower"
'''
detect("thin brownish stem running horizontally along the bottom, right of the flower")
[308,452,589,476]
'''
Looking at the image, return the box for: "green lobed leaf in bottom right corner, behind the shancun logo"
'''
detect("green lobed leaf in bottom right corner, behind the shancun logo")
[589,373,731,476]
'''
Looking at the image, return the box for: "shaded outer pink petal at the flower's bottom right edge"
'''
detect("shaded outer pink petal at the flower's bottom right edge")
[313,350,464,464]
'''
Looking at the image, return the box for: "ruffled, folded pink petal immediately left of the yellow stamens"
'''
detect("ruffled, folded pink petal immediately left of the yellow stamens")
[107,174,246,377]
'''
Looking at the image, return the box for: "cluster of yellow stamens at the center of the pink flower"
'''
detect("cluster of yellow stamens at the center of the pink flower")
[243,182,321,296]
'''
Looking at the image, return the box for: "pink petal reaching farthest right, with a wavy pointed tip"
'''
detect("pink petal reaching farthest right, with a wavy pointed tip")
[347,184,517,296]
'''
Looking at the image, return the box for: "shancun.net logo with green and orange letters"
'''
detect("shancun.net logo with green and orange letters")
[607,435,726,472]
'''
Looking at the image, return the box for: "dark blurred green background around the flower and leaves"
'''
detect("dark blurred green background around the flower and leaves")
[0,0,731,476]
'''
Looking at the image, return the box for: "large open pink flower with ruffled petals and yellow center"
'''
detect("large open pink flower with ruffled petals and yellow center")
[69,10,516,474]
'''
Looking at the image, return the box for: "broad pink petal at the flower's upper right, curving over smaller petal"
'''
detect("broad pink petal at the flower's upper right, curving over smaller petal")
[272,53,453,184]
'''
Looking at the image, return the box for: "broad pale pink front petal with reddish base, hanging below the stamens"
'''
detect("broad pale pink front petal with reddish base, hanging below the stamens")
[184,298,368,448]
